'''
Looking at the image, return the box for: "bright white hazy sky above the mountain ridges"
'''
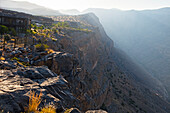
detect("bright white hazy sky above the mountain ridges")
[15,0,170,10]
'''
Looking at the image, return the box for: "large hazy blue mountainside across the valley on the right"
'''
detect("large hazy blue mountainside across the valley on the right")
[84,7,170,101]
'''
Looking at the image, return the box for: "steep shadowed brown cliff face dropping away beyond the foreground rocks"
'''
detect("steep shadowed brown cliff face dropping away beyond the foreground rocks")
[53,14,169,113]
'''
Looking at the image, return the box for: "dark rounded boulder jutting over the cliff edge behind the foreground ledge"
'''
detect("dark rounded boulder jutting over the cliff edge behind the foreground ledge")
[31,52,79,77]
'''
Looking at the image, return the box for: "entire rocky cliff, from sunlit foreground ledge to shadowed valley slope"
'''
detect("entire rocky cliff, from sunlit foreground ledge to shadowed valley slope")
[0,14,170,113]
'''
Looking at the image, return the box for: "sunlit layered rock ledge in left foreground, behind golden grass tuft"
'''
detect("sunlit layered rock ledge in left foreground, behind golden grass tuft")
[0,67,77,113]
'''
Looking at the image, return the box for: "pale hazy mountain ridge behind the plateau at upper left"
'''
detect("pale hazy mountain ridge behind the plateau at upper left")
[0,0,61,15]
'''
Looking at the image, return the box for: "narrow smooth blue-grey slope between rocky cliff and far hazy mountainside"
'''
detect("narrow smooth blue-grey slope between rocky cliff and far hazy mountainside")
[113,48,168,99]
